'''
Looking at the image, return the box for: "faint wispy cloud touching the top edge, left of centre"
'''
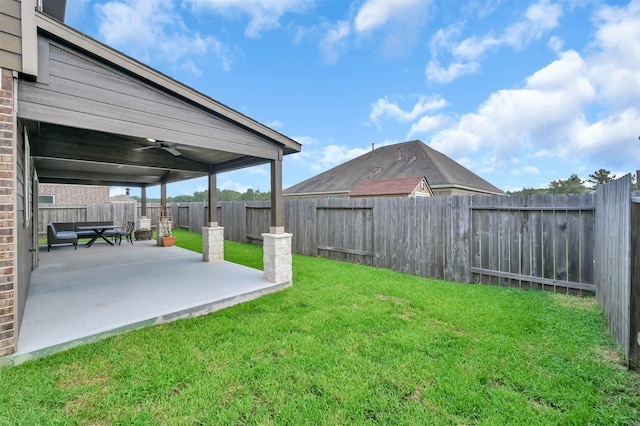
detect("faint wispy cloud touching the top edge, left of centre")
[188,0,313,38]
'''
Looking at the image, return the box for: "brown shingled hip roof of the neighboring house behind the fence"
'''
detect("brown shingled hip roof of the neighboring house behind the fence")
[283,140,504,196]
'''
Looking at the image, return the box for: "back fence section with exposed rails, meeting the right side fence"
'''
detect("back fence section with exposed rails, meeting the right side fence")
[470,194,595,291]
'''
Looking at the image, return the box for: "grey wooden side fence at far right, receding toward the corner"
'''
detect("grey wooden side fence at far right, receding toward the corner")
[595,175,638,366]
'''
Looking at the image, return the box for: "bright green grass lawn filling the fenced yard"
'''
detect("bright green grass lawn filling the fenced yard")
[7,230,640,425]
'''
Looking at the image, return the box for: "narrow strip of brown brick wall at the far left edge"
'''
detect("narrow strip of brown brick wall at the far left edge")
[0,69,16,356]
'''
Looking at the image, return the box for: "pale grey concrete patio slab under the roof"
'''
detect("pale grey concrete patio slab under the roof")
[10,240,291,363]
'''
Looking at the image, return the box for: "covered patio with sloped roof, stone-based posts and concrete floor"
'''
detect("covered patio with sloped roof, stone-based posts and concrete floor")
[0,0,301,357]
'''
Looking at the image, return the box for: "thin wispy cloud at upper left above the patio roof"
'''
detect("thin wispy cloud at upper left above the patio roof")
[94,0,231,75]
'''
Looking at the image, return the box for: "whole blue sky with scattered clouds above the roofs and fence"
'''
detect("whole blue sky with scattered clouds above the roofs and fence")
[66,0,640,197]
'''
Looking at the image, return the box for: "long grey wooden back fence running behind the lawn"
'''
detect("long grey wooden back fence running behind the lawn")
[204,194,595,292]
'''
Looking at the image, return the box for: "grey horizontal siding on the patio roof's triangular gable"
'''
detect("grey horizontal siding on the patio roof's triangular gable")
[18,35,277,159]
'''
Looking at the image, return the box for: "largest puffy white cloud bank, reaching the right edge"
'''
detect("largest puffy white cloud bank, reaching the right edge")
[430,0,640,174]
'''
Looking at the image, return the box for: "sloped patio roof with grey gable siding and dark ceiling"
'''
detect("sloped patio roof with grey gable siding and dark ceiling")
[18,13,301,187]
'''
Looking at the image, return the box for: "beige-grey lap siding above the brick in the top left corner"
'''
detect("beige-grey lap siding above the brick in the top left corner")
[0,0,22,71]
